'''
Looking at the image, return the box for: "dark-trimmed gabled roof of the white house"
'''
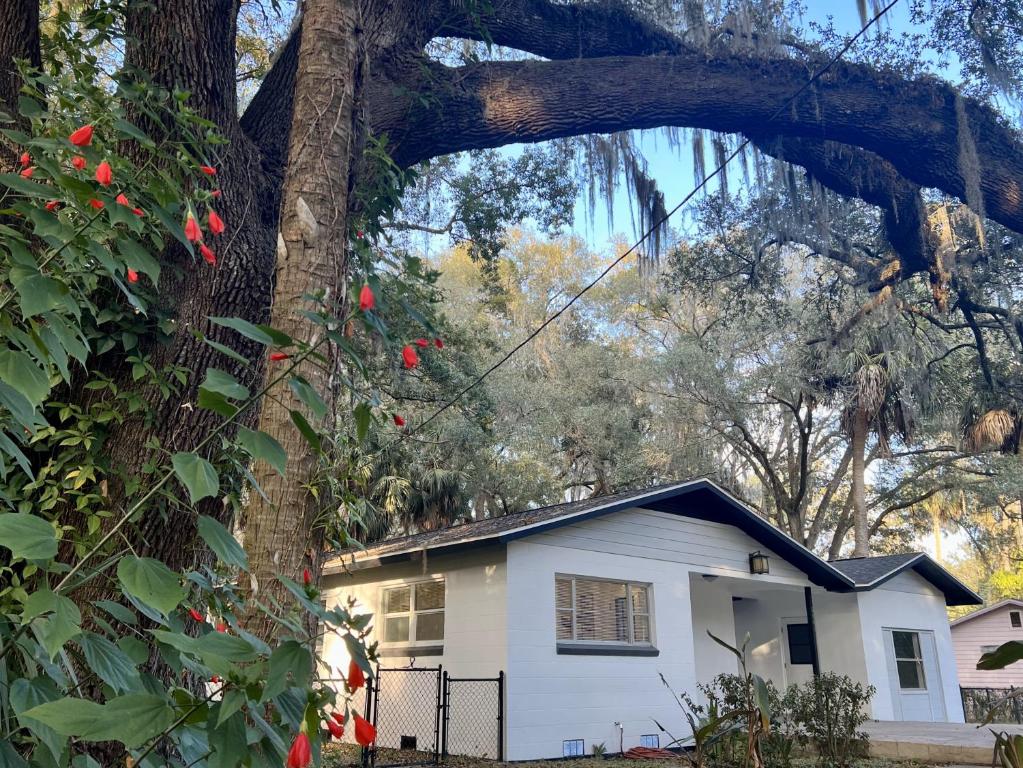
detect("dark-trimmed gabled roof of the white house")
[325,478,980,605]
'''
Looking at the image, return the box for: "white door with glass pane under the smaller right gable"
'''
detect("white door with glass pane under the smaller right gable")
[884,629,947,722]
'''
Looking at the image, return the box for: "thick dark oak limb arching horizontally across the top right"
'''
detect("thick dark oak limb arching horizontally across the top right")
[370,53,1023,231]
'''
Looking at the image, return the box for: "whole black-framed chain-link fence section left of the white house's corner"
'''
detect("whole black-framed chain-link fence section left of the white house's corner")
[356,667,504,768]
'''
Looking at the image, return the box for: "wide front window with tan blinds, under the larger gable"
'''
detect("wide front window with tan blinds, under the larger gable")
[554,576,653,645]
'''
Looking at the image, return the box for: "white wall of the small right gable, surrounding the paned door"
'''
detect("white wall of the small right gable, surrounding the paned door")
[857,572,963,723]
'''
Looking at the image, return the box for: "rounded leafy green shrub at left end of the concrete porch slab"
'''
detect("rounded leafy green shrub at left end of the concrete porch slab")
[782,672,876,768]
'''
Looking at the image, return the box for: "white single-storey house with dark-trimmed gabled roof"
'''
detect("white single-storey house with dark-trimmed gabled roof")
[323,480,981,760]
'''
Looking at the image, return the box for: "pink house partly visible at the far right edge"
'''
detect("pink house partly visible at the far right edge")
[951,599,1023,688]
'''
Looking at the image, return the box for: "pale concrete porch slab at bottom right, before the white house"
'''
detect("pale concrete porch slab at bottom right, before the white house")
[863,721,1023,765]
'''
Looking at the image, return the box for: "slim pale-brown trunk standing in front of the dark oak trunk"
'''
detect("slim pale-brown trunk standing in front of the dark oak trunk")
[244,0,364,640]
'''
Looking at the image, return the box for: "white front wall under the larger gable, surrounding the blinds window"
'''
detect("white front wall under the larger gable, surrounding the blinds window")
[507,509,818,760]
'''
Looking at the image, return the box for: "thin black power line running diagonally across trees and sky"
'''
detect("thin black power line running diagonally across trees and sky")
[381,0,899,451]
